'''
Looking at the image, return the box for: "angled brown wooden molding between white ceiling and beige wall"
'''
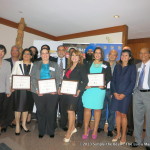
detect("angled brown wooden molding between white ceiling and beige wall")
[0,18,128,45]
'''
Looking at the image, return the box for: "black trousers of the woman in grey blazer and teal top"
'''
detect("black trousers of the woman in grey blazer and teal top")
[33,93,58,135]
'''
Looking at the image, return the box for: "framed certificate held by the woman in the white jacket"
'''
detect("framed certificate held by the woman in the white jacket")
[12,75,31,90]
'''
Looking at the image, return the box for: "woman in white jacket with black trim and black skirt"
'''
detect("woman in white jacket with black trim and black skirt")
[11,49,33,135]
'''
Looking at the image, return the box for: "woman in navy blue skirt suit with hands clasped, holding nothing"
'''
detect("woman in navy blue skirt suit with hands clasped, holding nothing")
[111,50,136,145]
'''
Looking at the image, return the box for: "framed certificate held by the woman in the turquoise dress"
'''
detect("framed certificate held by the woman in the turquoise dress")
[88,73,105,87]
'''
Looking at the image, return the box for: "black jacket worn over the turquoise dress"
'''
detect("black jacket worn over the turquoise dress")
[86,61,112,86]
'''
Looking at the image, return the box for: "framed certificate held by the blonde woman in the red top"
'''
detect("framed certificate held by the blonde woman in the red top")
[60,80,78,95]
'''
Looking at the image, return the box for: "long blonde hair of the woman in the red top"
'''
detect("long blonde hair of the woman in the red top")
[67,49,83,69]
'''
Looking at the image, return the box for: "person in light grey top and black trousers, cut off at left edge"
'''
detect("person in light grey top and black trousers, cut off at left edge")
[0,44,11,134]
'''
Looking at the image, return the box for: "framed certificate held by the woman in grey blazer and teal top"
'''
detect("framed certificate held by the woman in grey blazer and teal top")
[38,79,57,94]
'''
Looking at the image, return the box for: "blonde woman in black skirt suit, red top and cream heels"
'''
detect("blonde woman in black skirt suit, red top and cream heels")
[60,50,88,142]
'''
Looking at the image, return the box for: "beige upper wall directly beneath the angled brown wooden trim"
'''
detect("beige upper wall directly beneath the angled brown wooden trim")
[0,24,122,58]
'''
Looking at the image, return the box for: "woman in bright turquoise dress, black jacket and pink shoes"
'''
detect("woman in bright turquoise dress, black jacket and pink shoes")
[82,47,111,139]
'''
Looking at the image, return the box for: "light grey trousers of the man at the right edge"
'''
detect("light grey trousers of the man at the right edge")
[133,90,150,144]
